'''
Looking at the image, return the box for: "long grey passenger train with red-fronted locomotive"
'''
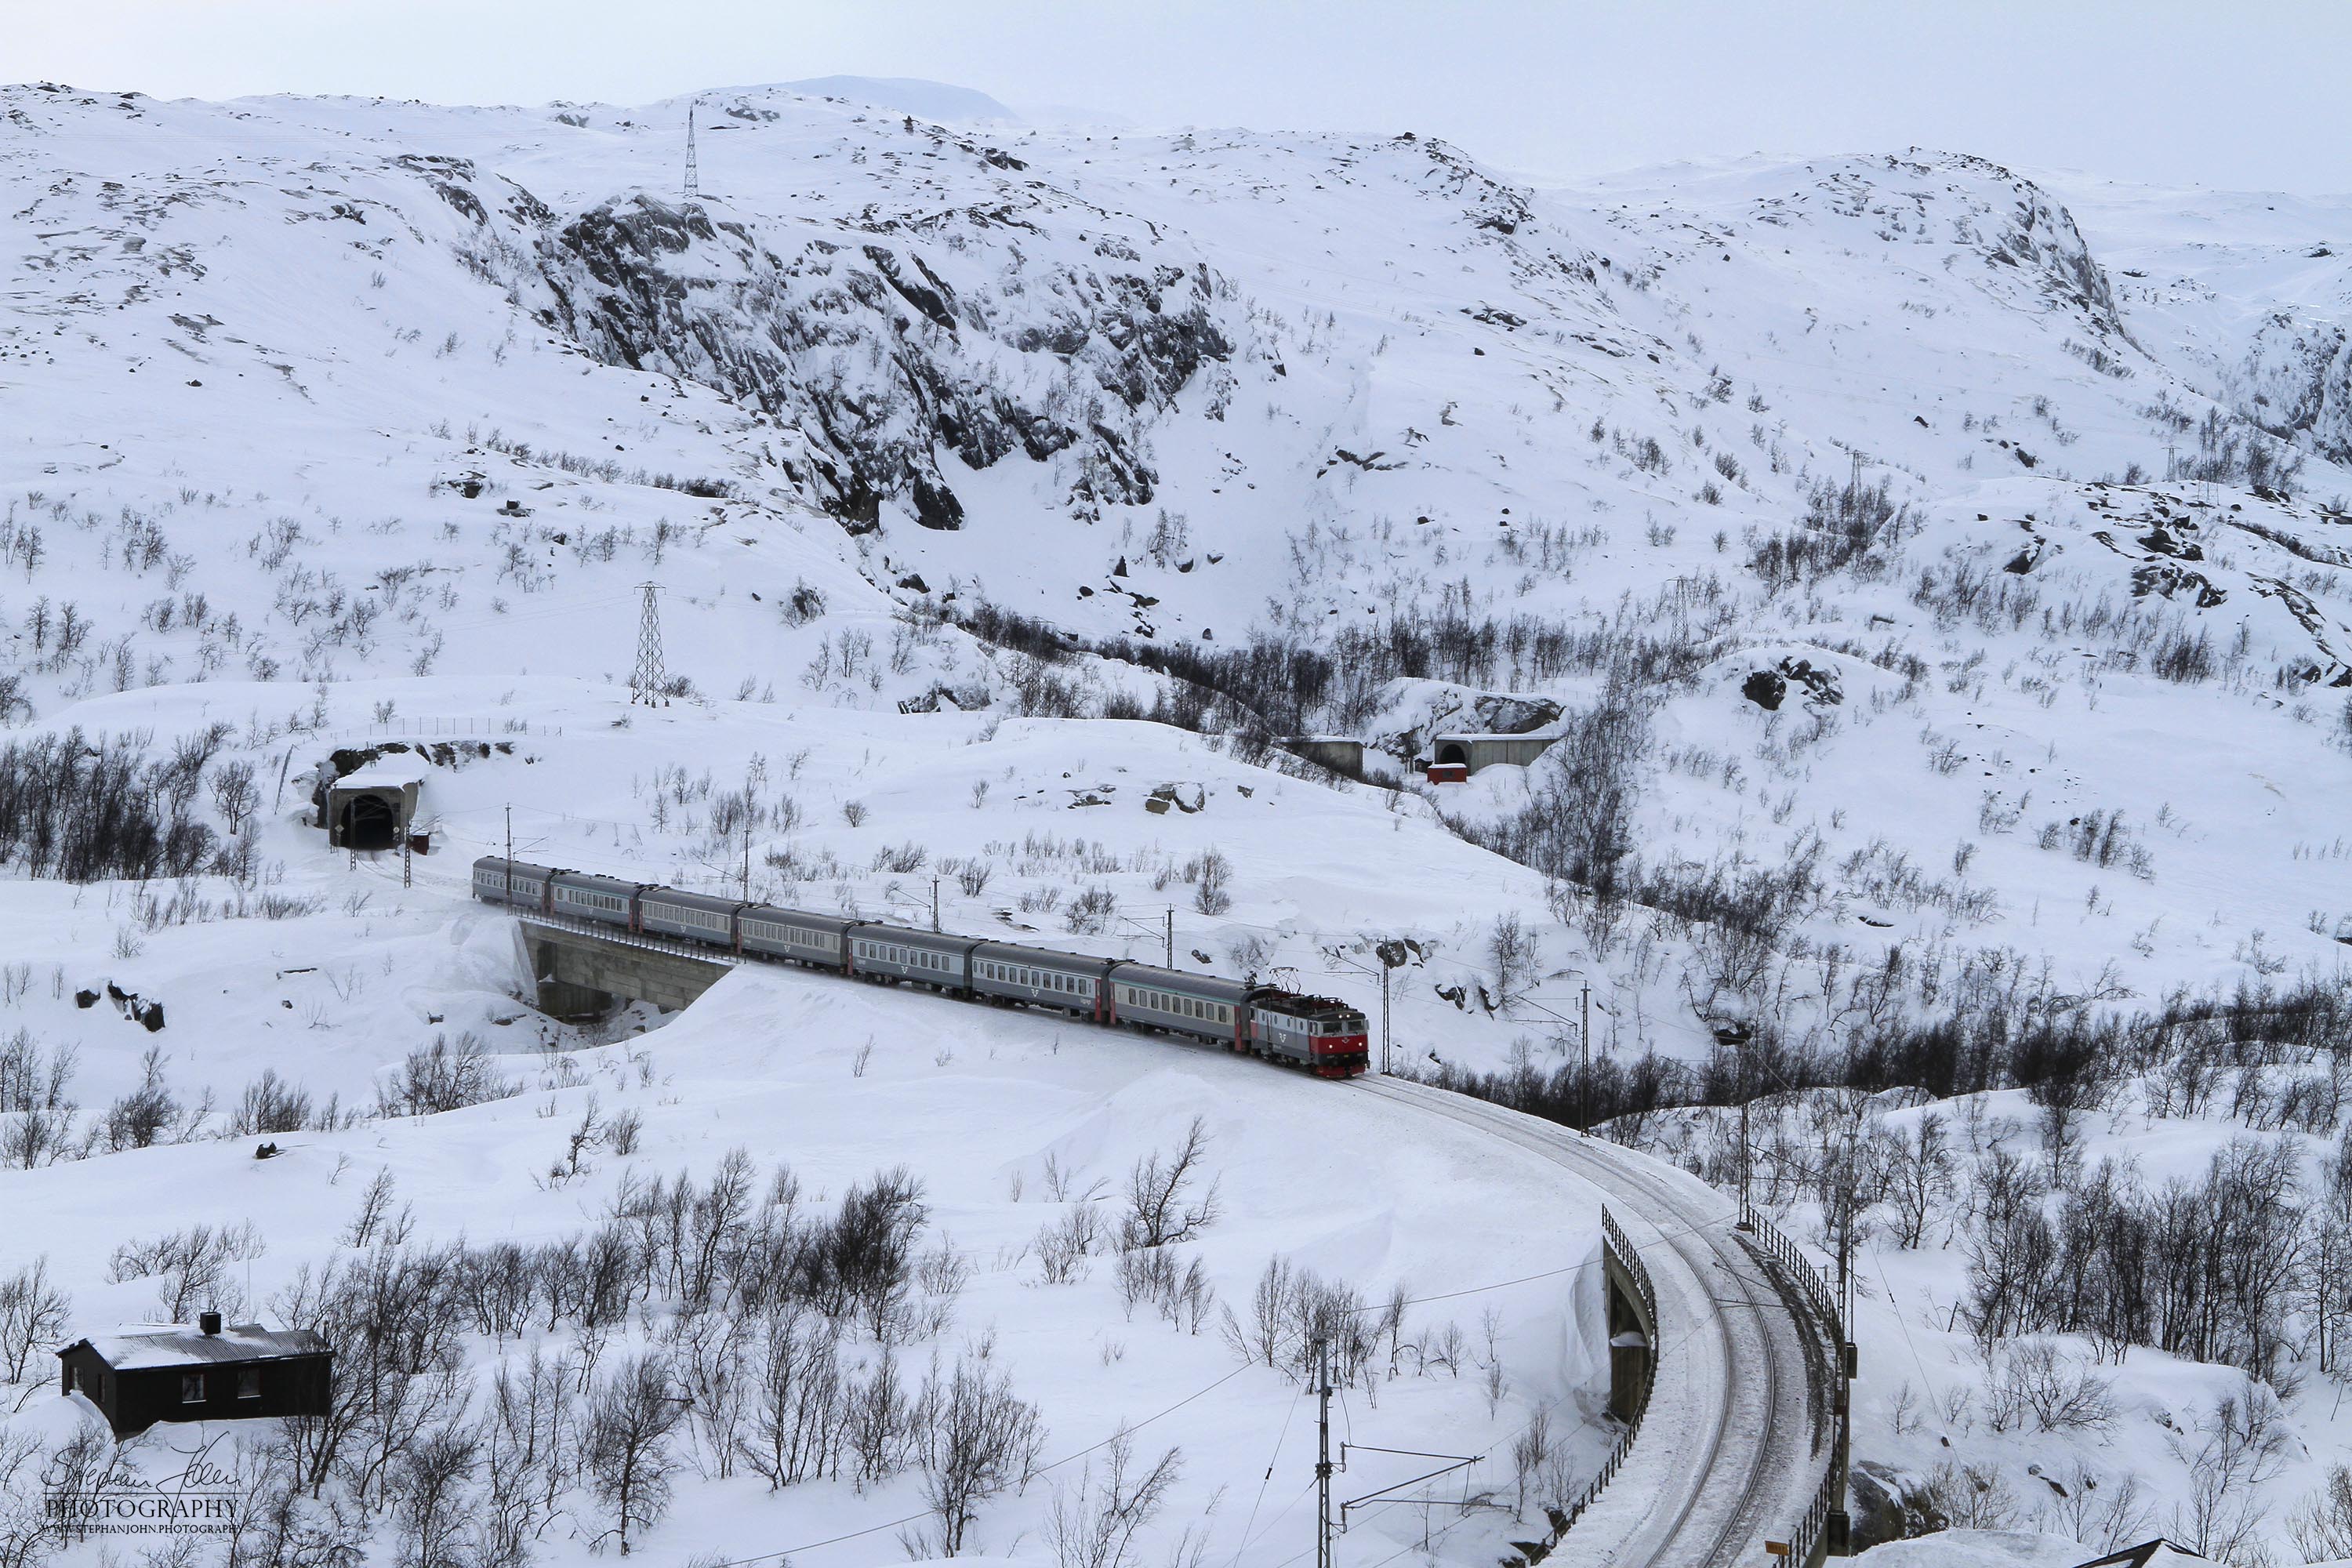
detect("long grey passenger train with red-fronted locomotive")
[473,855,1371,1079]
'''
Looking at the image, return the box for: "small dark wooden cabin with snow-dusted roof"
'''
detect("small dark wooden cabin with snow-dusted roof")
[56,1312,334,1436]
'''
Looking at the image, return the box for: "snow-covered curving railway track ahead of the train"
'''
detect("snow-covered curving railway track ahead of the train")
[1357,1079,1828,1568]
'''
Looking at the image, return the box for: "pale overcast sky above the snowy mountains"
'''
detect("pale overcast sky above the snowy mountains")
[18,0,2352,193]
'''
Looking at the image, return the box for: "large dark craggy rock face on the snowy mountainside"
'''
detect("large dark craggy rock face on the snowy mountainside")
[536,195,1232,529]
